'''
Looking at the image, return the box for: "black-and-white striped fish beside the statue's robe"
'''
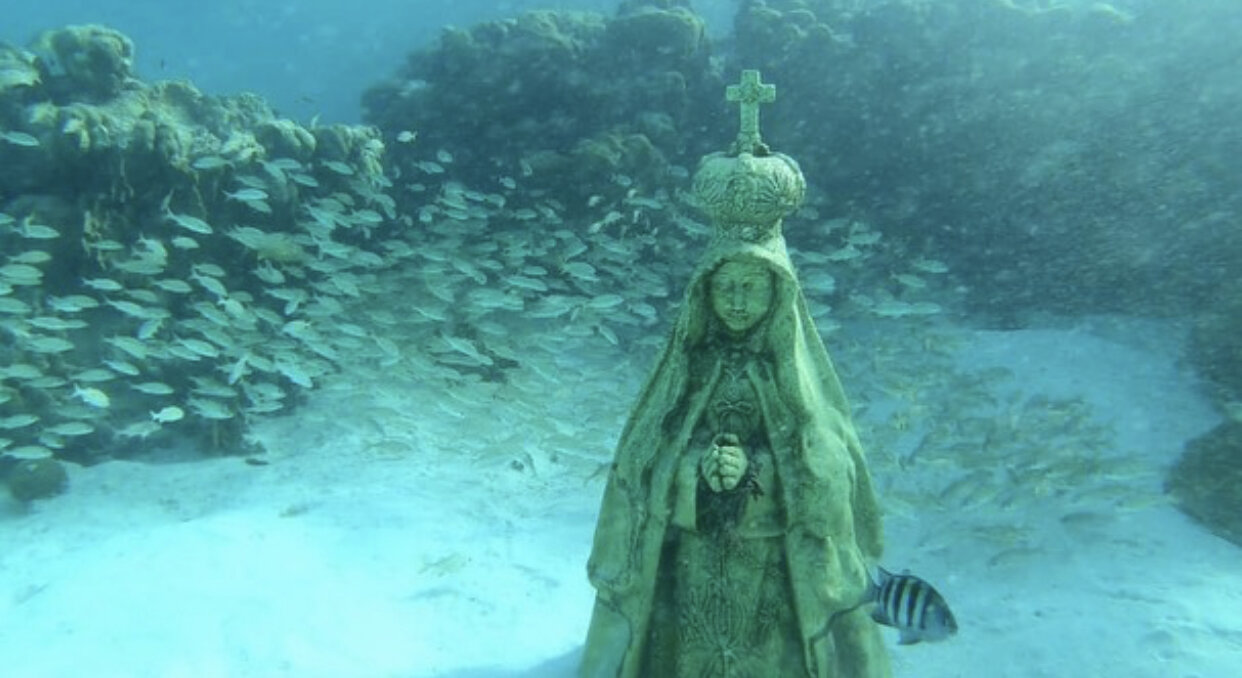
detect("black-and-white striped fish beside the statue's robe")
[868,567,958,644]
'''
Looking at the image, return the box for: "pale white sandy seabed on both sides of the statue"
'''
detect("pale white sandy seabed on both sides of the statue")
[0,314,1242,678]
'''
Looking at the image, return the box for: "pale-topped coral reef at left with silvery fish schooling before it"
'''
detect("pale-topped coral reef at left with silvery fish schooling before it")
[0,26,397,462]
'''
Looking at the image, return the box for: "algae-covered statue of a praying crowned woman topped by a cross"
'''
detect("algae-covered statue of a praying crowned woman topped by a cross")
[580,72,891,678]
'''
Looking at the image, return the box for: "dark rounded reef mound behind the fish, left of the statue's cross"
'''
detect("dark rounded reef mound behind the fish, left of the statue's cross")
[364,1,723,204]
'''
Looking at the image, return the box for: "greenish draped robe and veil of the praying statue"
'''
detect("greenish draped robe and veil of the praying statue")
[580,238,891,678]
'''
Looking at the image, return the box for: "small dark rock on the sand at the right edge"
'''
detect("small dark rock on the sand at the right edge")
[1166,421,1242,546]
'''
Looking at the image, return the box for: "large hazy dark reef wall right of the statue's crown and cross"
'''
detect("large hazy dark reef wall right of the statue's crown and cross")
[734,0,1242,327]
